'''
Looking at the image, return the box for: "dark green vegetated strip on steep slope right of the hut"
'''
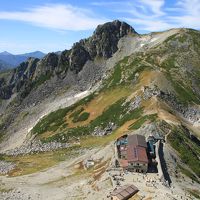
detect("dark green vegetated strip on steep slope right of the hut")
[168,127,200,177]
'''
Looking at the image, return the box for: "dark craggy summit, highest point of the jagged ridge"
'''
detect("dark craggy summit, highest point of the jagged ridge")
[66,20,137,72]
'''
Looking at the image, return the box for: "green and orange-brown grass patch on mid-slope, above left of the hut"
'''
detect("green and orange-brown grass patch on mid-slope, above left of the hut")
[32,57,150,142]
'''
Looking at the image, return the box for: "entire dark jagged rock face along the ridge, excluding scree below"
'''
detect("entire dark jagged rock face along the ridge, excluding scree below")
[0,20,137,99]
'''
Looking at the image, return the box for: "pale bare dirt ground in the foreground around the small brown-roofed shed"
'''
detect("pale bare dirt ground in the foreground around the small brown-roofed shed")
[0,143,199,200]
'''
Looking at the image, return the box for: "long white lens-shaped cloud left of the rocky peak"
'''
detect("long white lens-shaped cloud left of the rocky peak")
[0,4,107,31]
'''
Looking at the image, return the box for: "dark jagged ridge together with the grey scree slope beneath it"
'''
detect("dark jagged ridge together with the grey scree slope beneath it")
[0,21,137,147]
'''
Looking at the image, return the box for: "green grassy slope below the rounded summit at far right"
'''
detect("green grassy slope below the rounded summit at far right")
[145,30,200,105]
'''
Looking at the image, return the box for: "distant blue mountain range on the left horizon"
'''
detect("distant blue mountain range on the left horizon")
[0,51,46,71]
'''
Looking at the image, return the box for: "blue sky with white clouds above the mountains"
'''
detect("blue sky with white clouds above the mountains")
[0,0,200,54]
